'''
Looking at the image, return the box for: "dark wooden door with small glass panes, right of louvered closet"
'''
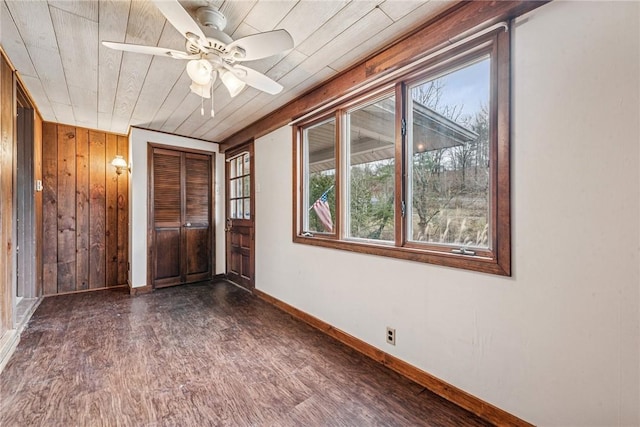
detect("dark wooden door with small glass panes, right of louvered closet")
[225,143,255,289]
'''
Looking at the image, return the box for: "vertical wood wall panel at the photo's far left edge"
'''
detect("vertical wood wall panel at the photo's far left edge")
[0,57,15,339]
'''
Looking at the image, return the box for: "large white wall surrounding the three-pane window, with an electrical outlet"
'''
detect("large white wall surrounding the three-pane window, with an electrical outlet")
[255,2,640,426]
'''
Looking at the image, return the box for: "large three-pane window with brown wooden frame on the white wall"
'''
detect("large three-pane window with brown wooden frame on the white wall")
[294,31,511,275]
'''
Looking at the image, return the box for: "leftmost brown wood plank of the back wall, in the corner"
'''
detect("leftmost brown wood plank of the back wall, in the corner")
[42,122,58,295]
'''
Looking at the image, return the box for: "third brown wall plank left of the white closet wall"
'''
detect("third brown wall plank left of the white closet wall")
[89,131,106,289]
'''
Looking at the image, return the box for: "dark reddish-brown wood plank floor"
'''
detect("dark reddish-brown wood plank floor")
[0,282,486,427]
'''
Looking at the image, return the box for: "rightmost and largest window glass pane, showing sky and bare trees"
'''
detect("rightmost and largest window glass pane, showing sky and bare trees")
[407,57,491,248]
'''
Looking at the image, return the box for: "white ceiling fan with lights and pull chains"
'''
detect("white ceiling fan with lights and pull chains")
[102,0,293,117]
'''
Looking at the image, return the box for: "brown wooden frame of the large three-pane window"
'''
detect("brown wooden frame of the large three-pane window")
[293,28,511,276]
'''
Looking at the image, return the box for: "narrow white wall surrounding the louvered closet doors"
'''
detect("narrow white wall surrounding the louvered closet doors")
[129,128,225,287]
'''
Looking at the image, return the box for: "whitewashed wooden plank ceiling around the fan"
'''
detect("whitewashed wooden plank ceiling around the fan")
[0,0,454,141]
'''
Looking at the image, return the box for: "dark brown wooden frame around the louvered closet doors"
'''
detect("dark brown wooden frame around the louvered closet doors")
[147,142,216,291]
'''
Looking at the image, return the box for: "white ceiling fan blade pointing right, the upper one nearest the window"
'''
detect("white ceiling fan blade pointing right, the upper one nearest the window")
[227,30,293,61]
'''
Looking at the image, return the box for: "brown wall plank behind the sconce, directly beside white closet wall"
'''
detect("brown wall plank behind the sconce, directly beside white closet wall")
[116,136,129,285]
